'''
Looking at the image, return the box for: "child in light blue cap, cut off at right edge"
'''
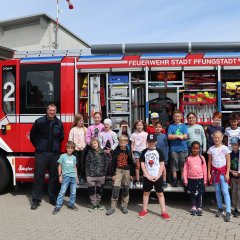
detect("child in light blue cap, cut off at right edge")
[229,137,240,217]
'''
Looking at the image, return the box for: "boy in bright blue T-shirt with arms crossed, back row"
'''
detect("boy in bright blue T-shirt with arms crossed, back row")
[168,110,188,187]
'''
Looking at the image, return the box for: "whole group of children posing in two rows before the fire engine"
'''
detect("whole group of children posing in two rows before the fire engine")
[53,110,240,221]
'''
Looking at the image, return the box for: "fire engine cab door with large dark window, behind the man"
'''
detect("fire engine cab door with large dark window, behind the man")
[19,63,60,152]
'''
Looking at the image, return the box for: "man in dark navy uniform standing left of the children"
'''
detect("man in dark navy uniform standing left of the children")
[30,103,64,210]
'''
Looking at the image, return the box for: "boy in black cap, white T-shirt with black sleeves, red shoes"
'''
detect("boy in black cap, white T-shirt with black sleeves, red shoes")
[138,134,170,221]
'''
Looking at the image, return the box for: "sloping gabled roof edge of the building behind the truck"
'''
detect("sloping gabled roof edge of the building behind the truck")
[0,13,90,48]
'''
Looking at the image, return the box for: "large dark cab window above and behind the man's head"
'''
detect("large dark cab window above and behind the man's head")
[21,64,60,114]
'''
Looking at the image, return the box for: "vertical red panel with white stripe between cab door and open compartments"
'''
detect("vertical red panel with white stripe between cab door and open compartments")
[60,58,75,152]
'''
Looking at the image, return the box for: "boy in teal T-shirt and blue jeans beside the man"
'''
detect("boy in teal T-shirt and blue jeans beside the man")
[52,141,78,215]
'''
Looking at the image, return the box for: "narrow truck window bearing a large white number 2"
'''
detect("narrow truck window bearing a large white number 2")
[2,66,16,114]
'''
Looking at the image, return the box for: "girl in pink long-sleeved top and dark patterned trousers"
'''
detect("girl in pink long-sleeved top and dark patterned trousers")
[183,141,207,216]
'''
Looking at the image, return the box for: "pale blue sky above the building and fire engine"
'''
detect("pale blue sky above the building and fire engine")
[0,0,240,44]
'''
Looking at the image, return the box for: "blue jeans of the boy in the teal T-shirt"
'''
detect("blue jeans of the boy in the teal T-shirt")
[56,176,76,208]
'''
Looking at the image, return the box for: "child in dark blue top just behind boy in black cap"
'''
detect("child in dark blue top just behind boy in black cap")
[155,122,169,187]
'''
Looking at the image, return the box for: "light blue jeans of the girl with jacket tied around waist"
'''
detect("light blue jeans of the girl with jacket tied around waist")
[215,175,231,213]
